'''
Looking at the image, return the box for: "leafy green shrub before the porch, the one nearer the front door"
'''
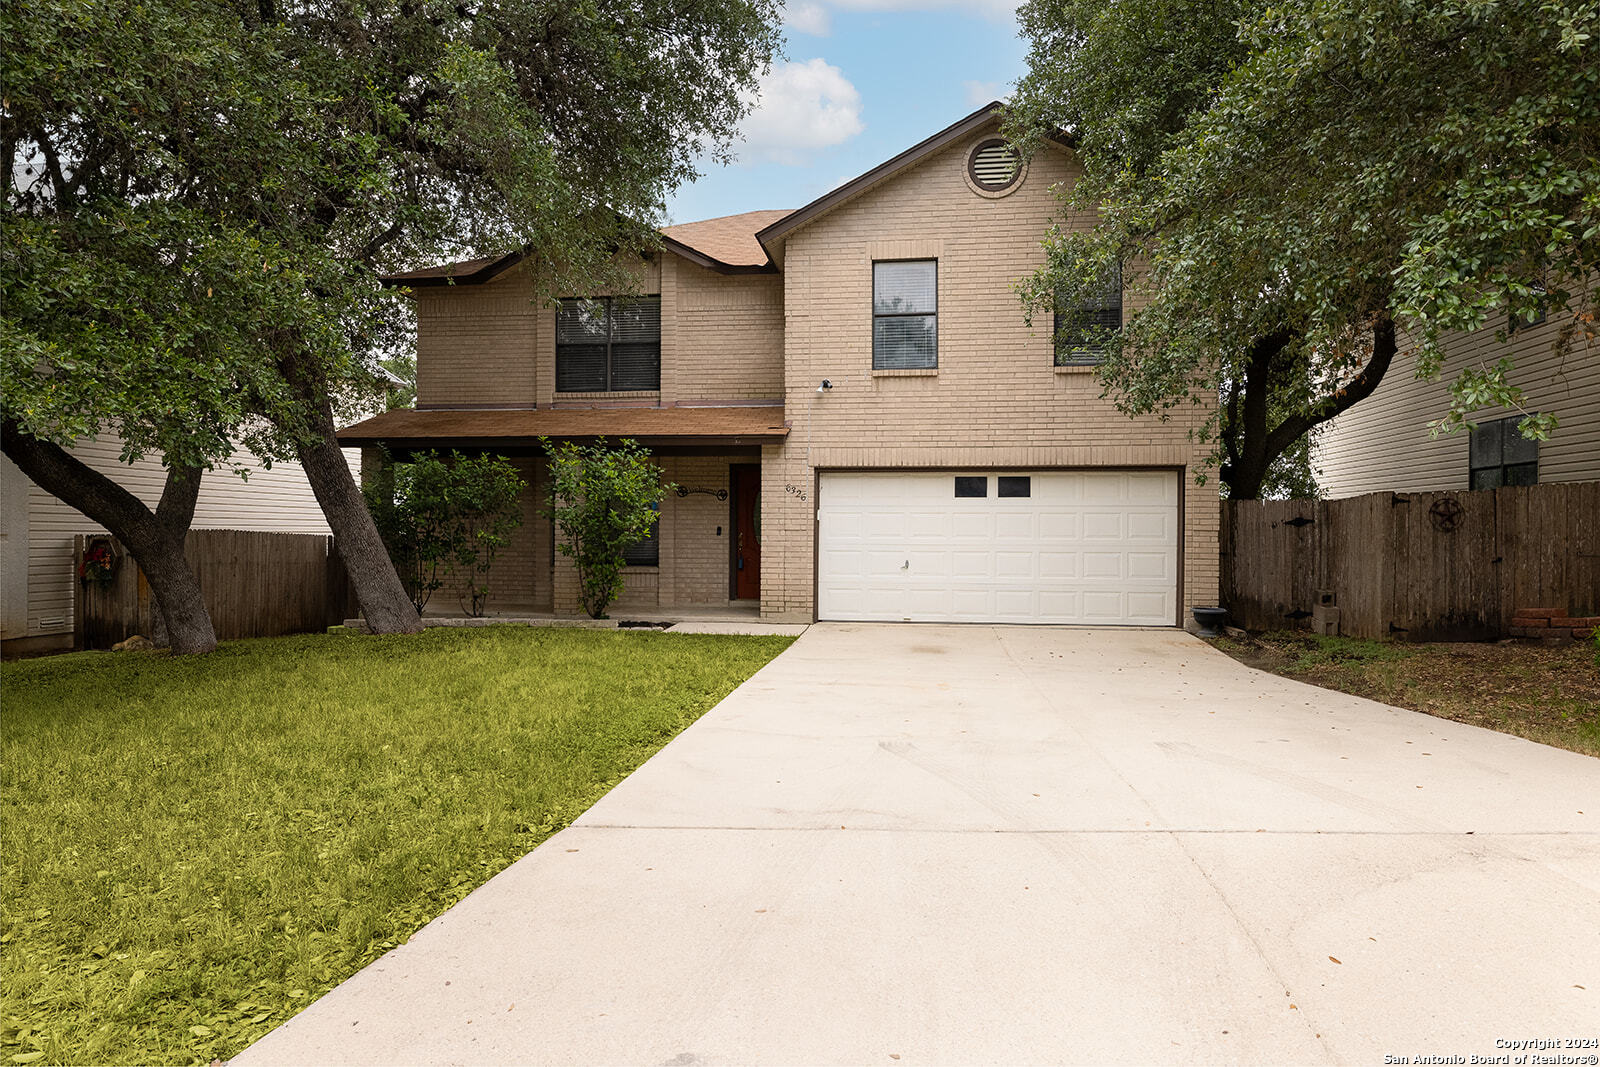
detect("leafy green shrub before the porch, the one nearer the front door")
[539,438,672,619]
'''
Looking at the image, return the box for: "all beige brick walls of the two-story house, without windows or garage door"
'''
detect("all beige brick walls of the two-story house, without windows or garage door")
[387,112,1219,622]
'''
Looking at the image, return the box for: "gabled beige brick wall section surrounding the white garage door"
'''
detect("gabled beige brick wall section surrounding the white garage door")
[762,134,1219,619]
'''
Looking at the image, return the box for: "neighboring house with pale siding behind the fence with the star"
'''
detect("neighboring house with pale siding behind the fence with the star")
[1312,307,1600,498]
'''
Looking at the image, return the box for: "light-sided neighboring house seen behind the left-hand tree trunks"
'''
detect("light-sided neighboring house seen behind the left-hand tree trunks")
[0,437,354,654]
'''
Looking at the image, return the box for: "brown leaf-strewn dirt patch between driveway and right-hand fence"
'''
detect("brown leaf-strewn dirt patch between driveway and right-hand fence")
[1214,632,1600,757]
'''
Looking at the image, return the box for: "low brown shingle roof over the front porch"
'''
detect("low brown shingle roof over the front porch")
[339,405,789,448]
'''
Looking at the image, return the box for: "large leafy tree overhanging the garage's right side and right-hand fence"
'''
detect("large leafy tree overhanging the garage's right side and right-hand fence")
[1014,0,1600,498]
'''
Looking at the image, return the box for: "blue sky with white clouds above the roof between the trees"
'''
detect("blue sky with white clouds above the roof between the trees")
[667,0,1027,222]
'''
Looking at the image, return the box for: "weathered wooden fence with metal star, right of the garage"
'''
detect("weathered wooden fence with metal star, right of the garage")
[1222,482,1600,641]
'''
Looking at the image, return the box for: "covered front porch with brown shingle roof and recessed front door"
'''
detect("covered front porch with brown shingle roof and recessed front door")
[339,406,787,622]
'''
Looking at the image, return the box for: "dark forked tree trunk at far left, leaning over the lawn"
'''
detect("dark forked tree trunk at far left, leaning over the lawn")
[0,422,216,654]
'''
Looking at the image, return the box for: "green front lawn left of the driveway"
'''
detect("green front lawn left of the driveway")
[0,627,790,1065]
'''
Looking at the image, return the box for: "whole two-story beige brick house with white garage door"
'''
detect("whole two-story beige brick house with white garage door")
[339,104,1219,625]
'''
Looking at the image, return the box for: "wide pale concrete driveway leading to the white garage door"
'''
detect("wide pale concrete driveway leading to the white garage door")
[235,624,1600,1067]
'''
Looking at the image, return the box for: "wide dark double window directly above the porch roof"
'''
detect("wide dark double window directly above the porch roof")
[555,296,661,392]
